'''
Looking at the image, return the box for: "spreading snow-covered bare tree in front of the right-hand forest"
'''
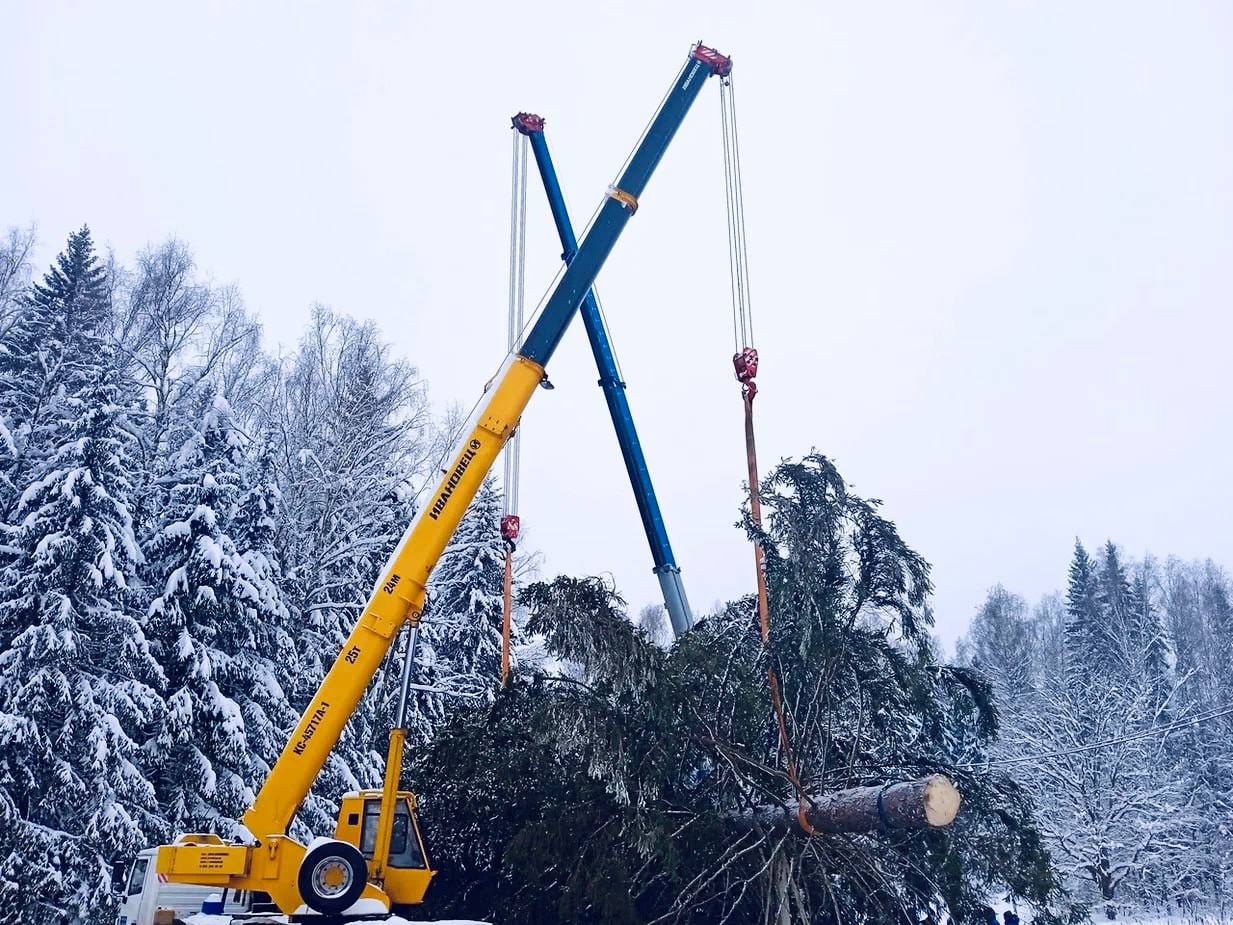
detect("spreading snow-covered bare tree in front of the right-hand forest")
[994,601,1196,919]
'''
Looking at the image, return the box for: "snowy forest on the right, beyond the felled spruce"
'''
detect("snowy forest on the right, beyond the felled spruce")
[958,541,1233,914]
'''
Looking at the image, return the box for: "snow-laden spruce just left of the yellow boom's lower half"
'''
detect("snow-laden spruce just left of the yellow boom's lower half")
[145,392,295,835]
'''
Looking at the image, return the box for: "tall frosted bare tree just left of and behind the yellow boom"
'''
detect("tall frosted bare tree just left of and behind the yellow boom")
[270,306,433,826]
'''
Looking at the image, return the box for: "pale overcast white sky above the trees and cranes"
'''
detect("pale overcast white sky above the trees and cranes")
[0,0,1233,640]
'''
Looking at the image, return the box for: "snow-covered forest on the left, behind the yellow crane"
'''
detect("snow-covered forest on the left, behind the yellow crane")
[0,228,503,924]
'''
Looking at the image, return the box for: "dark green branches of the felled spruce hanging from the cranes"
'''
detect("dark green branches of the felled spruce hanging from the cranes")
[413,455,1053,925]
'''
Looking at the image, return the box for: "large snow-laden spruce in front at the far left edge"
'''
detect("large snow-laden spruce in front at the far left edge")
[0,365,163,923]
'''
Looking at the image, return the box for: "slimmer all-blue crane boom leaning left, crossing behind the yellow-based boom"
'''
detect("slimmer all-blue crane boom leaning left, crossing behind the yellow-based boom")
[513,112,693,636]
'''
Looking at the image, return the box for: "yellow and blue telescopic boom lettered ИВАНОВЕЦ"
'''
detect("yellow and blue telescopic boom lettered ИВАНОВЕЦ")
[235,44,731,841]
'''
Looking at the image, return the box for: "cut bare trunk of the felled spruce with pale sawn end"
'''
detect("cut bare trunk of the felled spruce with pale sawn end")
[743,775,961,834]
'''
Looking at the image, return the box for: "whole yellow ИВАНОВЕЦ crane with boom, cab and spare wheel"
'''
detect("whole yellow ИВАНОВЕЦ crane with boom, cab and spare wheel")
[157,43,731,915]
